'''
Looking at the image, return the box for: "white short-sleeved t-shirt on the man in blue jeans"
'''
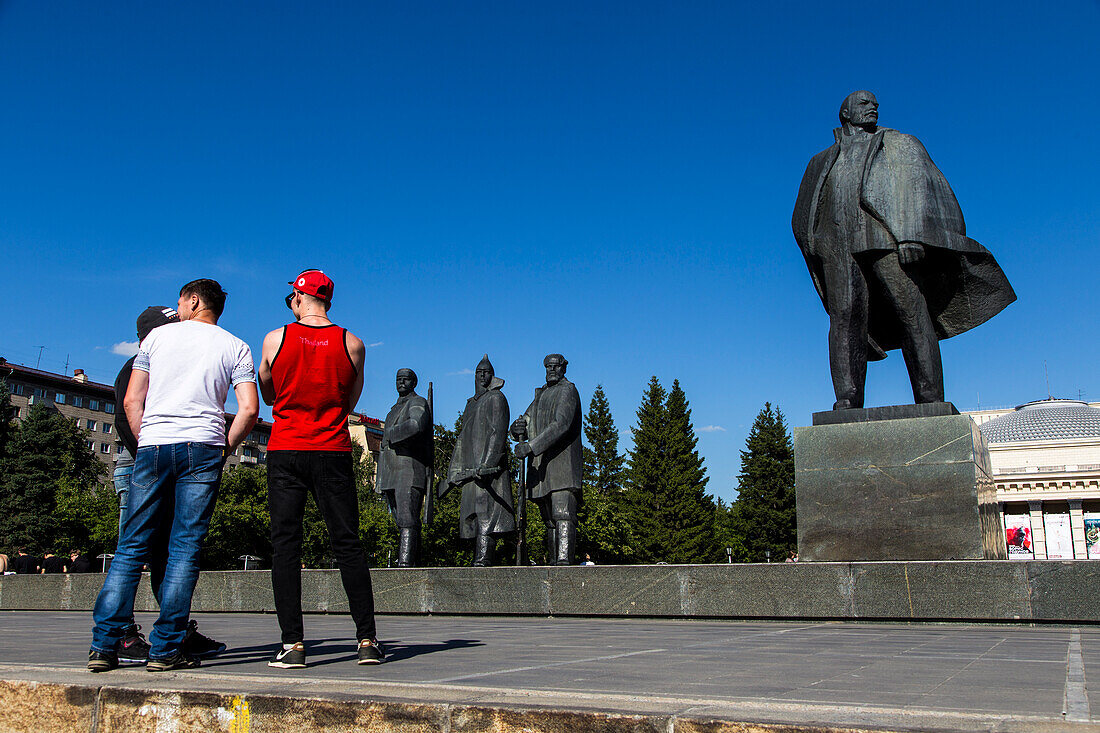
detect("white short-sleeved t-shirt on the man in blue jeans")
[133,320,256,447]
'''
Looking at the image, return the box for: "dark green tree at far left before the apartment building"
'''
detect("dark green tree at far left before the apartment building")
[0,404,106,551]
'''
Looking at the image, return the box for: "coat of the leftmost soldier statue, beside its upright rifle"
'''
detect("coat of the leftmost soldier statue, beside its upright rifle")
[375,393,435,493]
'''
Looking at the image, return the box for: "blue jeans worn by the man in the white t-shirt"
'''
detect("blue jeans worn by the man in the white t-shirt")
[91,442,222,659]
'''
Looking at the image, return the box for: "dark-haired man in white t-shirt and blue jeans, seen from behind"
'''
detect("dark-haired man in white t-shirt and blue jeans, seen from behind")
[88,280,260,671]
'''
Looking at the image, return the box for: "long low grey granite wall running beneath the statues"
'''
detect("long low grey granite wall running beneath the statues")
[0,560,1100,624]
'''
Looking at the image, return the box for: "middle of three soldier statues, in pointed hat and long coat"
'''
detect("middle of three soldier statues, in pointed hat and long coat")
[439,354,516,567]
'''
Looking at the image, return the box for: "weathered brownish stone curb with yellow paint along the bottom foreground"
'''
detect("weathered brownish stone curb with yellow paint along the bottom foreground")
[8,679,1100,733]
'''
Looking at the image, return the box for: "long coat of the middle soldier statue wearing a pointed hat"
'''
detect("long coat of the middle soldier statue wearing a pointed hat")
[448,376,516,539]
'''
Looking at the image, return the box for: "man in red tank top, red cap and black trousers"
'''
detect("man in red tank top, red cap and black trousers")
[257,270,385,669]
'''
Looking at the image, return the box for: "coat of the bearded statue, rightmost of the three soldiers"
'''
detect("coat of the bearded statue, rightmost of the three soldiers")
[524,376,584,499]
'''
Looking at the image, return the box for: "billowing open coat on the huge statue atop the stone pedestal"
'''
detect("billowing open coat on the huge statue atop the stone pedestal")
[791,128,1016,359]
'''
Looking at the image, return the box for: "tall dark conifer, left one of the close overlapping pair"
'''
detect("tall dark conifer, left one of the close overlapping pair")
[626,376,669,562]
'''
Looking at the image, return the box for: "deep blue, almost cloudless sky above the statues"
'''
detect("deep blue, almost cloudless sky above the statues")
[0,0,1100,500]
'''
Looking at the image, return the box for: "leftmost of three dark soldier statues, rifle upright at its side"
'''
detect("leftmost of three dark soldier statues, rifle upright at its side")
[375,369,435,568]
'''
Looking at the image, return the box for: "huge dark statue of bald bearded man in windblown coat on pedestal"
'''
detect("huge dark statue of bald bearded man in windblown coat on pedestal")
[791,90,1016,409]
